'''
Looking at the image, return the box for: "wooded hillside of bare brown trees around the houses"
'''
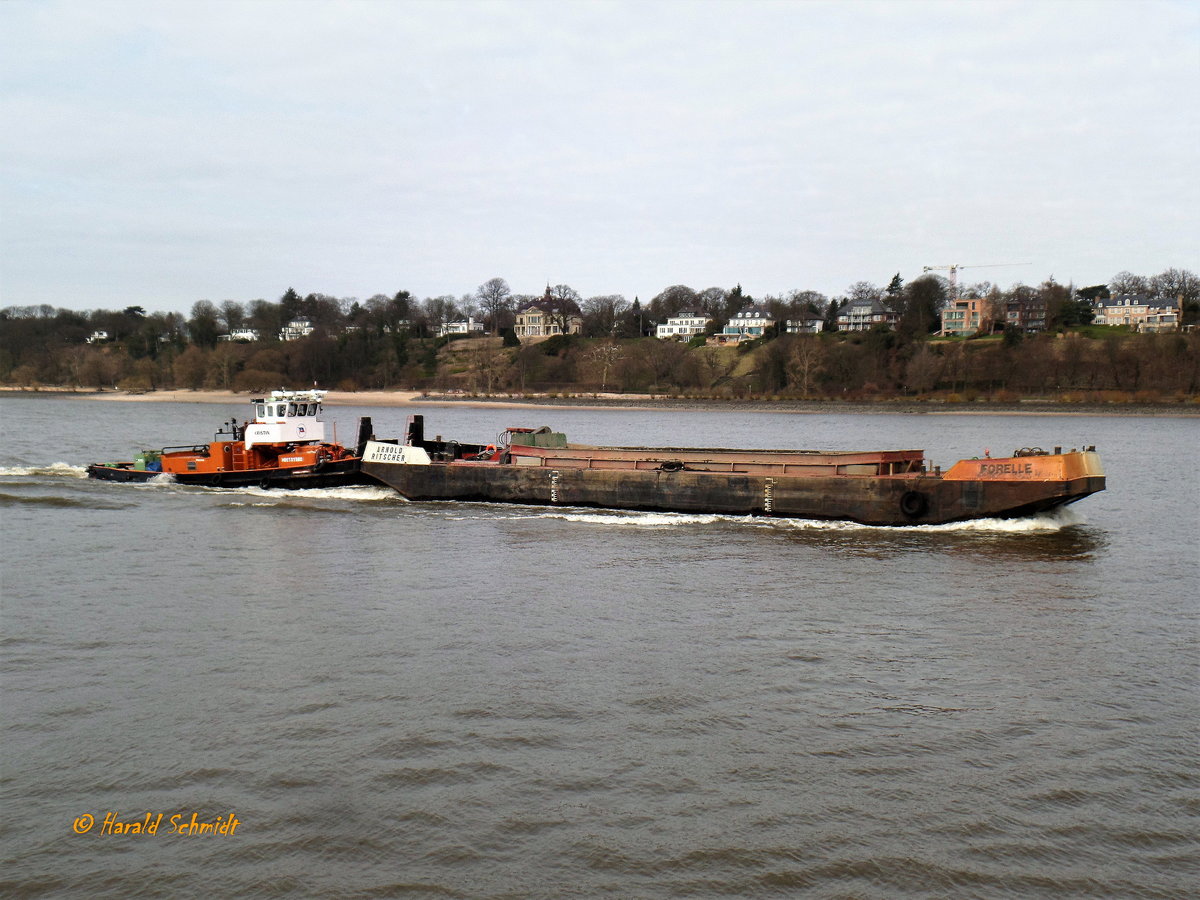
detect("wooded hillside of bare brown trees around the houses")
[0,264,1200,396]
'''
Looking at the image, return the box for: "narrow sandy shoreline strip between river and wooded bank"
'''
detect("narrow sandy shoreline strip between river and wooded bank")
[0,388,1200,418]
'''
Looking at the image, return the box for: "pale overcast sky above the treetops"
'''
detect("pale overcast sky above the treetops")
[0,0,1200,312]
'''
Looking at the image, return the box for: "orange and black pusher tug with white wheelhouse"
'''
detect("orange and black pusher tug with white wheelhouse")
[88,390,372,488]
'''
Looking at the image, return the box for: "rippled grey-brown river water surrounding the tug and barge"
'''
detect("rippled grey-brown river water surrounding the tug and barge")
[0,396,1200,898]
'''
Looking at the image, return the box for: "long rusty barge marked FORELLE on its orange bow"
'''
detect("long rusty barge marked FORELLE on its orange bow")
[362,415,1105,526]
